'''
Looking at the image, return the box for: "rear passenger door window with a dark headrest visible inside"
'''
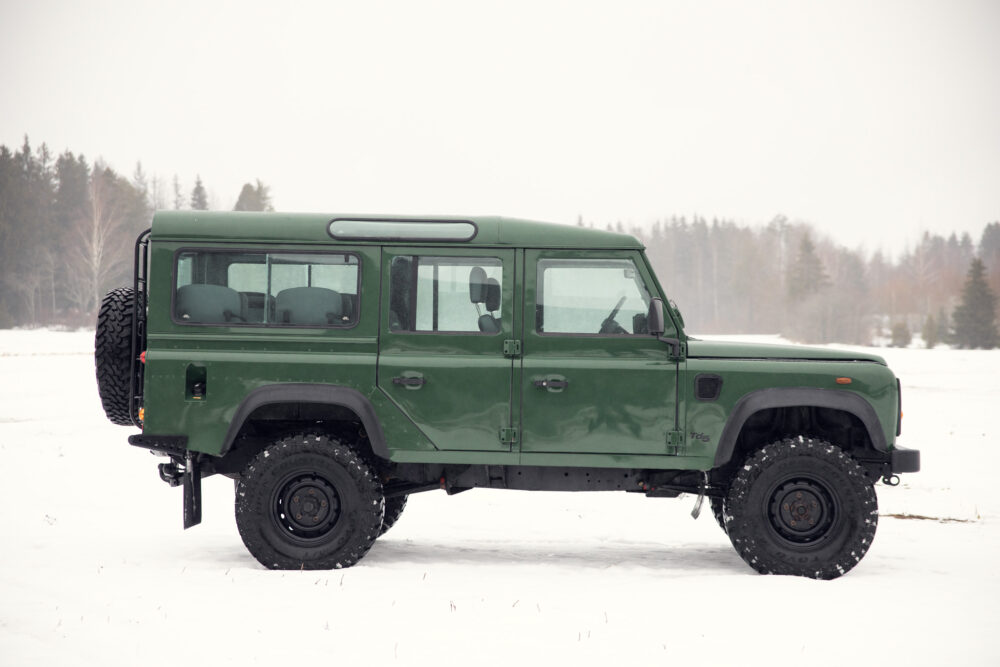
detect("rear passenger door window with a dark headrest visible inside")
[389,256,503,334]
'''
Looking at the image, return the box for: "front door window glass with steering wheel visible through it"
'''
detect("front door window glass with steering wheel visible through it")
[536,259,650,335]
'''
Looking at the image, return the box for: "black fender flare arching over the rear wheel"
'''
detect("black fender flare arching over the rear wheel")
[220,383,389,459]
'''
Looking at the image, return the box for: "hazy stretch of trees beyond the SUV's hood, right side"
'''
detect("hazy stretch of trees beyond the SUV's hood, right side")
[592,216,1000,348]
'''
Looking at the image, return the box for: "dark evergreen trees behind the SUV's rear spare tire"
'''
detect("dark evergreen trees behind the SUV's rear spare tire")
[0,138,273,328]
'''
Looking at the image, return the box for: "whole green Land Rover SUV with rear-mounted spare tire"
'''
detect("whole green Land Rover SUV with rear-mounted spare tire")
[95,211,920,579]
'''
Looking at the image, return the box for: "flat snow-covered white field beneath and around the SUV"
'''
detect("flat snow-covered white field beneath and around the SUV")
[0,331,1000,667]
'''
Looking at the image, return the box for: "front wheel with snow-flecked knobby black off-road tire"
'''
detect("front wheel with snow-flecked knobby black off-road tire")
[725,436,878,579]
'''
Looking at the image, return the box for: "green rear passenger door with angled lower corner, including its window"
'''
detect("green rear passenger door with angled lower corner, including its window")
[378,247,515,451]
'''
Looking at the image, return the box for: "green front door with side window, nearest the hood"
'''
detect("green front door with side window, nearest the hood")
[521,250,677,454]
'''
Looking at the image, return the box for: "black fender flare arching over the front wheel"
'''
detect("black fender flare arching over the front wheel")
[714,387,889,468]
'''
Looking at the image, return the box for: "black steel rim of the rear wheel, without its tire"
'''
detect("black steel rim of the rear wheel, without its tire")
[271,473,341,543]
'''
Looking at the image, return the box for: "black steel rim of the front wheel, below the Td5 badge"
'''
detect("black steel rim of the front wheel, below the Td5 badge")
[766,475,842,547]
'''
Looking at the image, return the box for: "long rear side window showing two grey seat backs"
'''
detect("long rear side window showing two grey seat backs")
[173,250,360,327]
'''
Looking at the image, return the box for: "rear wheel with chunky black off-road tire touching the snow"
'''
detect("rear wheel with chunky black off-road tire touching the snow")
[236,434,385,570]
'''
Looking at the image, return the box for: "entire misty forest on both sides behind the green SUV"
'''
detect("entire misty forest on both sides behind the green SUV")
[0,138,1000,347]
